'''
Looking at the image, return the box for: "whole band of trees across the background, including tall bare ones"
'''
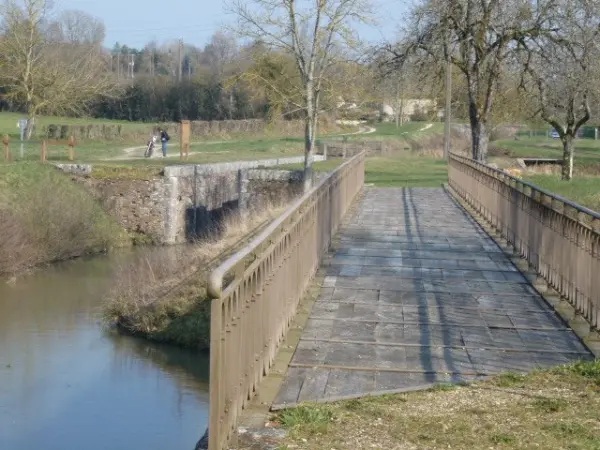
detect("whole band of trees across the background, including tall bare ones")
[0,0,600,186]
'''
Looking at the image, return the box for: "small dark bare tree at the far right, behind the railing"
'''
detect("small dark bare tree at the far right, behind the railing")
[519,0,600,180]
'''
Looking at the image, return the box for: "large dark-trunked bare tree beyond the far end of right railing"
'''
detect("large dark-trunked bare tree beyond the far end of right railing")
[391,0,553,161]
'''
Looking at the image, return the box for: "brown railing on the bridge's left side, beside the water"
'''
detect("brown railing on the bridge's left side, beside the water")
[208,153,364,450]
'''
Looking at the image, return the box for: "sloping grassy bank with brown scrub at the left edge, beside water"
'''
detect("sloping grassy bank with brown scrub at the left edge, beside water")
[0,163,127,275]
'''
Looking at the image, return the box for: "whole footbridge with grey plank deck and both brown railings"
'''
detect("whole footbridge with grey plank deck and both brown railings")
[204,154,600,450]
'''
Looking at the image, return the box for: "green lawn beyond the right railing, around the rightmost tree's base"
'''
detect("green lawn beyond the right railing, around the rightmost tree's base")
[490,138,600,211]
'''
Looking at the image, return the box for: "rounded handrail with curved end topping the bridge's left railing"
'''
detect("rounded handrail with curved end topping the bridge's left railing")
[207,152,362,298]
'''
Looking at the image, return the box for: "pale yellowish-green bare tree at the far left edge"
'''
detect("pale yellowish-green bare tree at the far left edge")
[0,0,119,138]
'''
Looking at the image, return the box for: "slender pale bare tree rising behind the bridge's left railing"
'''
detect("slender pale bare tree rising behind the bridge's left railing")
[230,0,370,191]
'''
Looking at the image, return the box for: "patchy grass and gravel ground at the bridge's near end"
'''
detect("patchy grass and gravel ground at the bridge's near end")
[277,361,600,450]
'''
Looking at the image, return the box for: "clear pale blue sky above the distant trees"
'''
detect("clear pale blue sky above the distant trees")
[53,0,408,48]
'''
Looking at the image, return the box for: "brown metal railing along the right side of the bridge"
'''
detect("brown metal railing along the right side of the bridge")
[448,154,600,328]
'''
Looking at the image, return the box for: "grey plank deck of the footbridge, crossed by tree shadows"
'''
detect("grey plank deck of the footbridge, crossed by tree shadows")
[273,189,592,409]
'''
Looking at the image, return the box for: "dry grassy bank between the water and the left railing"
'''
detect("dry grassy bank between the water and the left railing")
[102,204,285,350]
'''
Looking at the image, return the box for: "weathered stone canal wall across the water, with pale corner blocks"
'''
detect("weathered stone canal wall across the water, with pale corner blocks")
[73,156,330,244]
